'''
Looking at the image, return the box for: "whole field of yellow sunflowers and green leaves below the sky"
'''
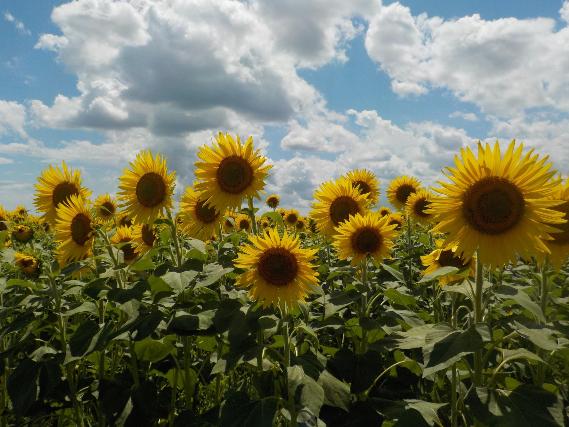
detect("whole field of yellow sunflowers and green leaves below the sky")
[0,133,569,427]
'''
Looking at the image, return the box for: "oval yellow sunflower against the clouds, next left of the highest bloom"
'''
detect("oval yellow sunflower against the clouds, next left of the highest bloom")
[118,151,176,223]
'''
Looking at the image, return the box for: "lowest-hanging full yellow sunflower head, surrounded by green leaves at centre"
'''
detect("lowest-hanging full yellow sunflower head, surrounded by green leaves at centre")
[235,229,318,306]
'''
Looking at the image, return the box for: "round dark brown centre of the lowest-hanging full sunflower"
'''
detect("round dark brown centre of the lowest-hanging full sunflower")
[257,248,298,286]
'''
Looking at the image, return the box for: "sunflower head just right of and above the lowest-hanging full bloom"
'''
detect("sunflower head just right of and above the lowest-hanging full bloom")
[334,212,397,265]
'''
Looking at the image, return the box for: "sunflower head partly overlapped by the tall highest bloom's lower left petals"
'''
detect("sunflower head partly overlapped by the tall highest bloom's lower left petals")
[180,187,221,240]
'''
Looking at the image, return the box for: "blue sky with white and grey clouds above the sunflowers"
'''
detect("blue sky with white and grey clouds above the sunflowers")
[0,0,569,213]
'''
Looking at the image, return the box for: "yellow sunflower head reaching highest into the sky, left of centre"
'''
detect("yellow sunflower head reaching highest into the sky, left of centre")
[195,132,271,212]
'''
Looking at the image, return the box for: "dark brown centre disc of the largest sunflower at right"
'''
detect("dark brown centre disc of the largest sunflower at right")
[463,177,525,234]
